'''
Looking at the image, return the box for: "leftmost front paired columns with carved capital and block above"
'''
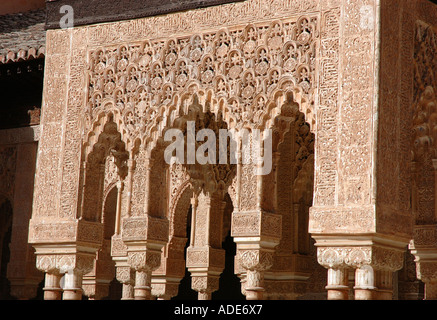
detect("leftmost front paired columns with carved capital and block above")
[29,219,103,300]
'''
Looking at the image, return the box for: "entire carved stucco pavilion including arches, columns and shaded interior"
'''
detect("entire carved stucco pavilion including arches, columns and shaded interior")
[22,0,437,300]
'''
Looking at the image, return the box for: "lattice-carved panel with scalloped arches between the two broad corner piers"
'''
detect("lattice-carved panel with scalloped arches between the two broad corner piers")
[32,6,319,299]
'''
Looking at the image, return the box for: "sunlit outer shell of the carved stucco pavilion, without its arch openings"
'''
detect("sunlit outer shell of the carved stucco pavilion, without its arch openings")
[29,0,435,299]
